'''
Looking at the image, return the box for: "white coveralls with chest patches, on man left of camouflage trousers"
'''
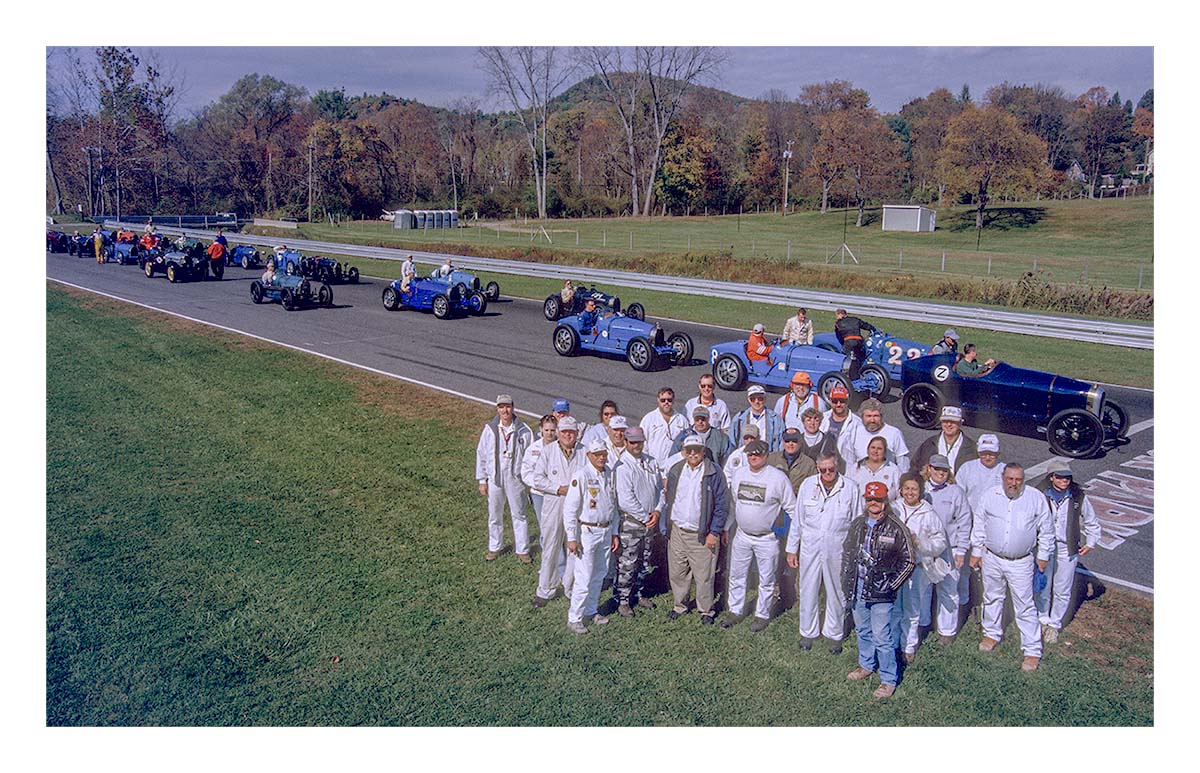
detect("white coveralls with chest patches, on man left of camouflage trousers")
[563,461,619,623]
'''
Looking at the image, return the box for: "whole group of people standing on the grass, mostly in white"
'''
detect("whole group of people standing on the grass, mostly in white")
[475,373,1100,699]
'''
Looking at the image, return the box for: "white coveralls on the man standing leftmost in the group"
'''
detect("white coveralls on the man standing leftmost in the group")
[475,419,533,555]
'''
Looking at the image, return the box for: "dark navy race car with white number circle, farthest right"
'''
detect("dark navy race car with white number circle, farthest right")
[900,354,1129,459]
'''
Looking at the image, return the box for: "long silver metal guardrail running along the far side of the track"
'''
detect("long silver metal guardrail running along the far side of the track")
[106,221,1154,349]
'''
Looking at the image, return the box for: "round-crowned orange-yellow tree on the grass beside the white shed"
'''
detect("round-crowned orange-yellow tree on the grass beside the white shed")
[937,106,1046,230]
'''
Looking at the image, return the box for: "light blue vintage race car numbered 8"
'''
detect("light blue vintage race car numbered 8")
[708,338,892,402]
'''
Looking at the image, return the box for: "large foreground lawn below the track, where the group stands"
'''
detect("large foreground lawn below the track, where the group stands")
[46,284,1153,726]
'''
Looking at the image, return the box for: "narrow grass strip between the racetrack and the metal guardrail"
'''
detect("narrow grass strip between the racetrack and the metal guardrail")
[290,250,1154,389]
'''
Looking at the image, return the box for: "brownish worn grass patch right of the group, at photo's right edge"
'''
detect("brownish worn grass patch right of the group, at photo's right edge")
[1057,588,1154,682]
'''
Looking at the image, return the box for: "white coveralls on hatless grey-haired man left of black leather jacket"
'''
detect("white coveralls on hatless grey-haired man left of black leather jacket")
[787,475,863,641]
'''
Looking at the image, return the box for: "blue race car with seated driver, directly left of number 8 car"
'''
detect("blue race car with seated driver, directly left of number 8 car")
[553,312,692,371]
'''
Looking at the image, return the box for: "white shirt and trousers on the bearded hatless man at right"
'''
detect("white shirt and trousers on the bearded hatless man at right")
[971,485,1054,658]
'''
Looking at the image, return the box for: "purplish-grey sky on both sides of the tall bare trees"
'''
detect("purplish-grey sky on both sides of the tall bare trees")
[49,47,1154,118]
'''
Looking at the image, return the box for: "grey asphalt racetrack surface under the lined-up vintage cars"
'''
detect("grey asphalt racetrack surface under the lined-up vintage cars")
[46,253,1154,593]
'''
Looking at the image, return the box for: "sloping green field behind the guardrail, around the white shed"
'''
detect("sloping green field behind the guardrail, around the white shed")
[262,197,1154,290]
